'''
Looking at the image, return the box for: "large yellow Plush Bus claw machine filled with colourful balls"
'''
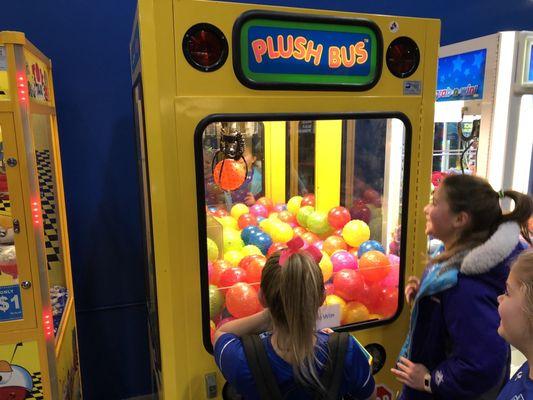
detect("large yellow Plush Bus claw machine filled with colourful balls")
[130,0,439,400]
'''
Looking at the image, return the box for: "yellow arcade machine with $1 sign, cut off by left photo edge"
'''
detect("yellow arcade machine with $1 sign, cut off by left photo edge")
[0,31,81,400]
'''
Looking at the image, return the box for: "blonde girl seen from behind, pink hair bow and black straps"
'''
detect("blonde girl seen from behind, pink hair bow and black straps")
[215,237,375,400]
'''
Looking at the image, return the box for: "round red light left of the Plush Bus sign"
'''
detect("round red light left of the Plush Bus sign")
[183,24,228,72]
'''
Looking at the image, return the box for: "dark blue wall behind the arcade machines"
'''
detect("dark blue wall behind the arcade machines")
[0,0,533,399]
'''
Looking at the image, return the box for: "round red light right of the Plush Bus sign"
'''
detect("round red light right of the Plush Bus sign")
[385,36,420,78]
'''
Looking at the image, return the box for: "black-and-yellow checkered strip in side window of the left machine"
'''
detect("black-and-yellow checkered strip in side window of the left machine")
[35,150,61,269]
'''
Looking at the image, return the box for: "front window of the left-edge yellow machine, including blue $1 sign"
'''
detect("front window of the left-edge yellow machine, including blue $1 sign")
[0,126,22,322]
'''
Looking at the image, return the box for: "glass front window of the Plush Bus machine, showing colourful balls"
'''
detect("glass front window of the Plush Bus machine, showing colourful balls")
[198,118,406,340]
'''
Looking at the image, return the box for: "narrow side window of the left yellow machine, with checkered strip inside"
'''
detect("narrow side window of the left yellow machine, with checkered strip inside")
[31,114,68,334]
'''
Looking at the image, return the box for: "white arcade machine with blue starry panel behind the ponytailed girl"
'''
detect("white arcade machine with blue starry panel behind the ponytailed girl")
[433,32,533,198]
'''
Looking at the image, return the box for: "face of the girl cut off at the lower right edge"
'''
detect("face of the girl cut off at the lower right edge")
[498,271,531,350]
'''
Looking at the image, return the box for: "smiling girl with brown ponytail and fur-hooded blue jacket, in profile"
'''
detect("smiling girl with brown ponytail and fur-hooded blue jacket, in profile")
[392,175,533,400]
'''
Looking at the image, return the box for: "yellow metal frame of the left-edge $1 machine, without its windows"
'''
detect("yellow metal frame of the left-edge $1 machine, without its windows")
[0,31,81,399]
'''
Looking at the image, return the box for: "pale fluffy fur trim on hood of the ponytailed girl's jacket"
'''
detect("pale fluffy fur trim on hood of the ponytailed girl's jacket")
[460,222,520,275]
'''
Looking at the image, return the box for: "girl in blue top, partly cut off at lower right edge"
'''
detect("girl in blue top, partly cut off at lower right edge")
[498,250,533,400]
